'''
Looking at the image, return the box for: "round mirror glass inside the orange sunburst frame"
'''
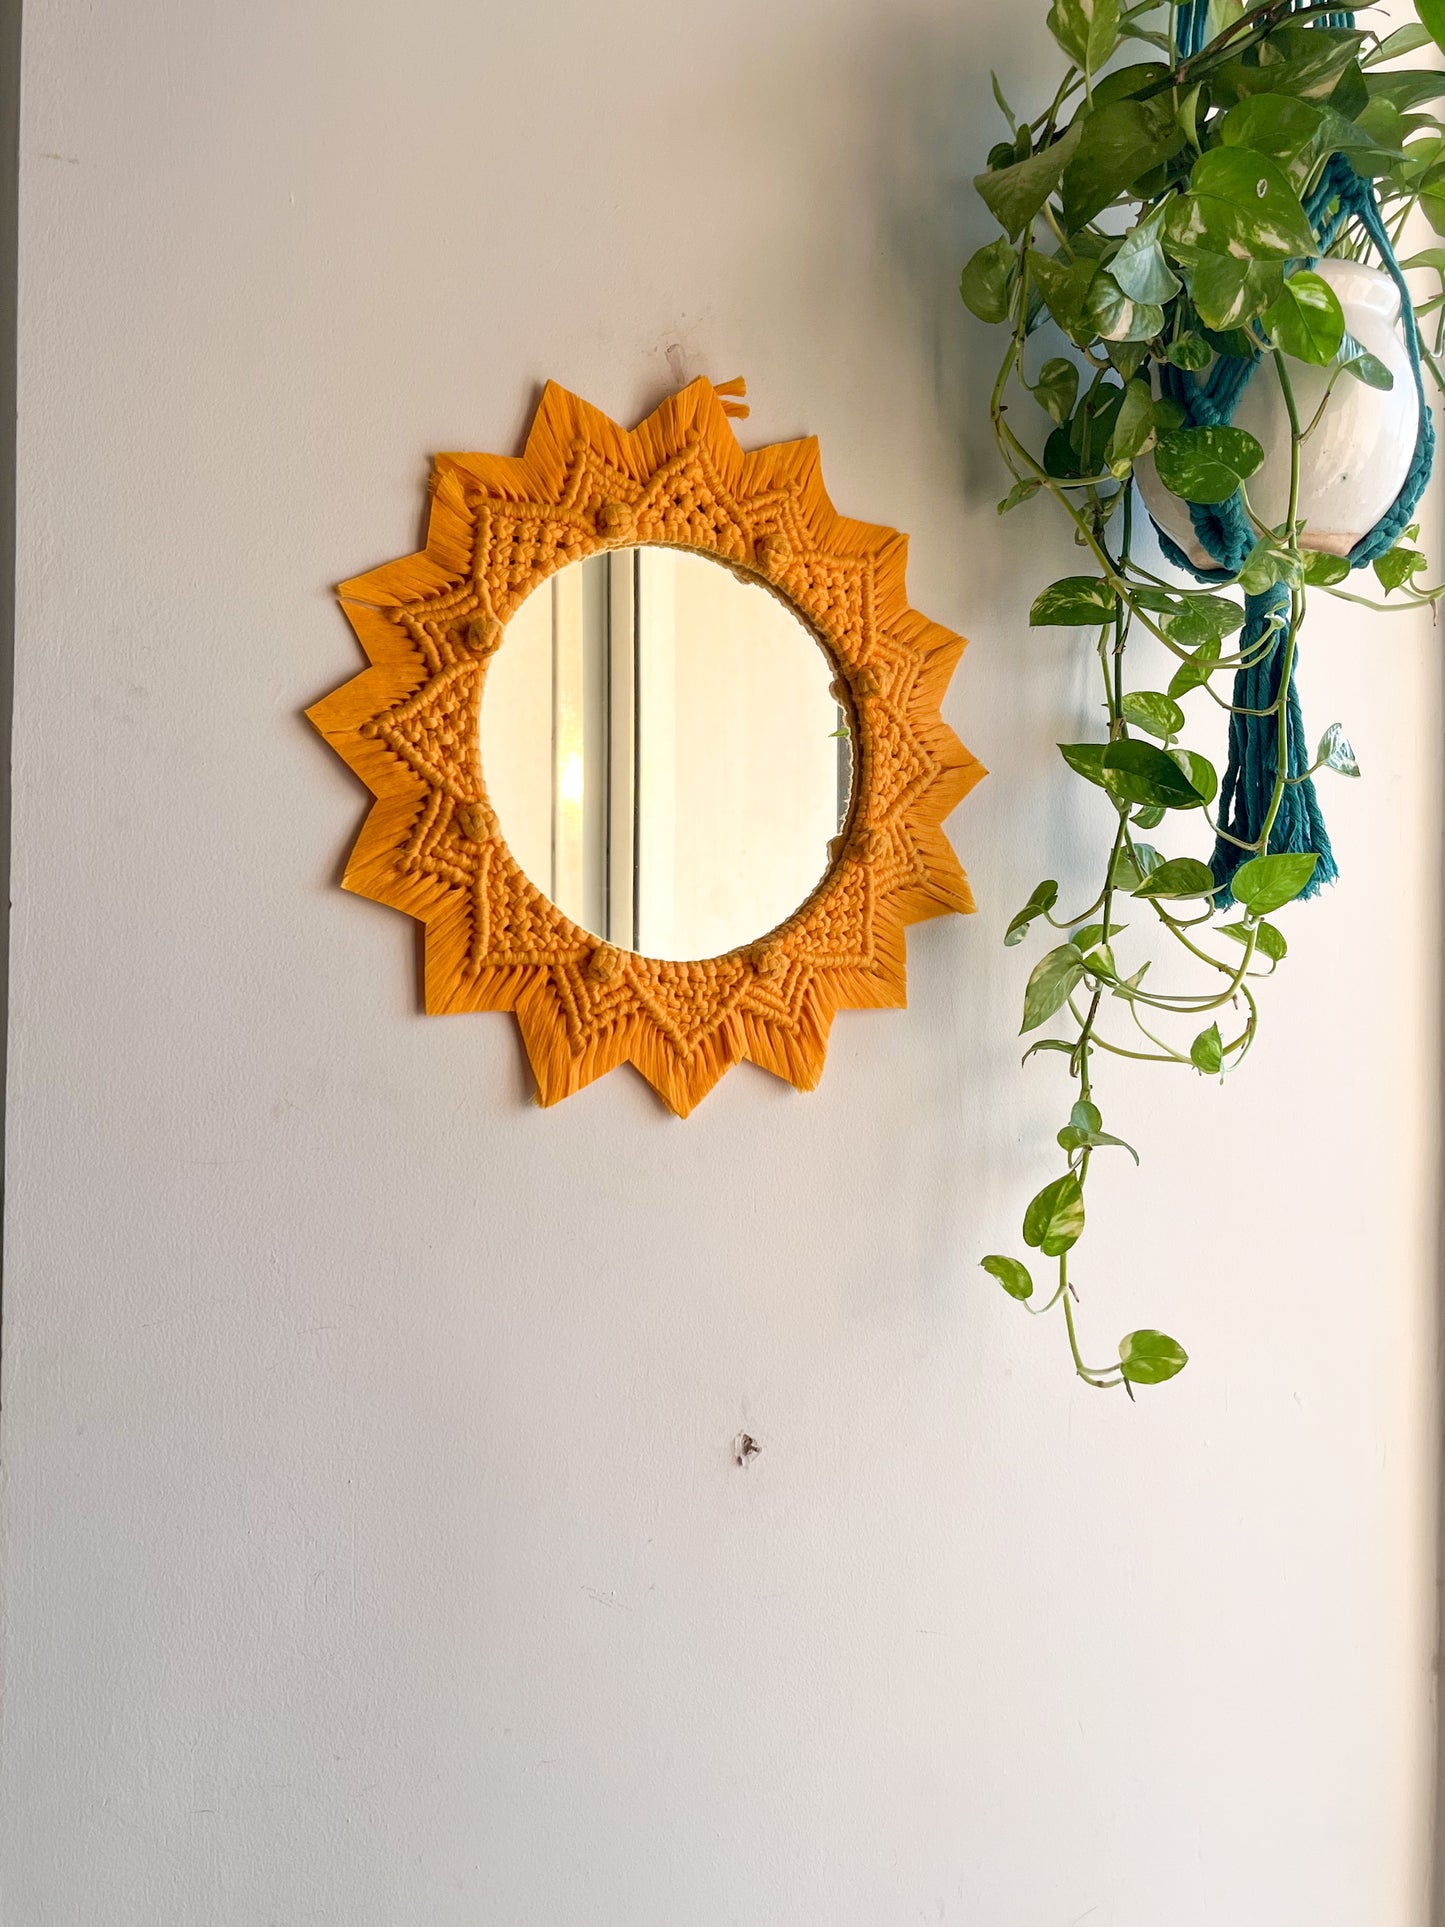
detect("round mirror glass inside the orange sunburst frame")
[482,547,852,962]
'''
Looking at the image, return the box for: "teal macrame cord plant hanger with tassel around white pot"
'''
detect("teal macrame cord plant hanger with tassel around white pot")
[1154,0,1435,902]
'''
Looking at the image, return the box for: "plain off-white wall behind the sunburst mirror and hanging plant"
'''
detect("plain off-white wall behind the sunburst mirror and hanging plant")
[0,0,1439,1927]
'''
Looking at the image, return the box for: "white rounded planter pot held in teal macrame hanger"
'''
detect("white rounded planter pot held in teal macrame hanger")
[1135,260,1420,568]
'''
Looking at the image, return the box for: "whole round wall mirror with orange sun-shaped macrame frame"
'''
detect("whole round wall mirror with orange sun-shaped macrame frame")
[308,382,983,1114]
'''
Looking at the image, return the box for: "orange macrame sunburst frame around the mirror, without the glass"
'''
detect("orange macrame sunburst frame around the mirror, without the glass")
[306,382,983,1116]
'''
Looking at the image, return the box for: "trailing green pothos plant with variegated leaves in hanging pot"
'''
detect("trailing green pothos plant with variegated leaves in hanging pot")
[961,0,1445,1389]
